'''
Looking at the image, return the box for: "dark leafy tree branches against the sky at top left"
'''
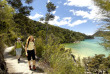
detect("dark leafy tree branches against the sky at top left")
[7,0,33,16]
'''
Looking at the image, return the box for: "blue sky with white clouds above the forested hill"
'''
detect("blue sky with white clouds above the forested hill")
[28,0,103,35]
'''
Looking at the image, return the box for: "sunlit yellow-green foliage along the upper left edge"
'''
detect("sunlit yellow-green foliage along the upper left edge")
[0,0,14,34]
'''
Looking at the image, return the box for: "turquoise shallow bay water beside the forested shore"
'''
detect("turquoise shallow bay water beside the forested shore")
[65,37,110,57]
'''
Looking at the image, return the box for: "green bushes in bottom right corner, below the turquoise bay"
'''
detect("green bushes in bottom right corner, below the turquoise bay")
[83,54,110,73]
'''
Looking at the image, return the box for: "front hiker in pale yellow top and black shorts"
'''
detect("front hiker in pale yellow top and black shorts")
[25,36,36,70]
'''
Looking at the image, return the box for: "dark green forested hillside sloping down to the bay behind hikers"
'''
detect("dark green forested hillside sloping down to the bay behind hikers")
[6,16,87,43]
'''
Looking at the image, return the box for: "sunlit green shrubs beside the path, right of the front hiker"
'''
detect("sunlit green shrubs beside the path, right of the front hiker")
[36,34,84,74]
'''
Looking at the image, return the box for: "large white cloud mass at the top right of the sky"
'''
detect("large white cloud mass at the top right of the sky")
[64,0,104,21]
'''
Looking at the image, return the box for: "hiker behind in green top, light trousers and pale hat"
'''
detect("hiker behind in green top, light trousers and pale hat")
[15,38,24,63]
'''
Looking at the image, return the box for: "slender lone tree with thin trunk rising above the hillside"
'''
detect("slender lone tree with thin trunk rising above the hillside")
[40,2,56,44]
